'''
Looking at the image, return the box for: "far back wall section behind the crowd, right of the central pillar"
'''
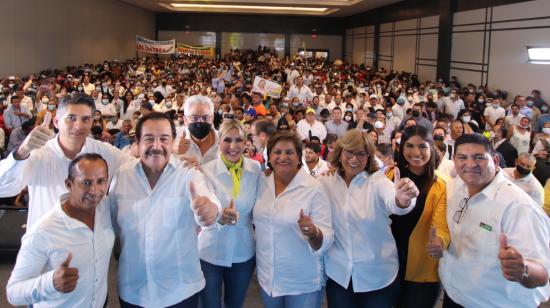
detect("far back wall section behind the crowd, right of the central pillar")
[290,34,342,61]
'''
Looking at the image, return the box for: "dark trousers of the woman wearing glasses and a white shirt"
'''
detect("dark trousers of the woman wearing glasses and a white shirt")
[326,278,397,308]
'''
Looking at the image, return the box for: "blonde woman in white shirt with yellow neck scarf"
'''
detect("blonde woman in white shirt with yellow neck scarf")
[199,120,262,308]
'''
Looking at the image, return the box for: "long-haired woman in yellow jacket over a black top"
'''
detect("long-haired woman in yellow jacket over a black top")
[388,125,450,308]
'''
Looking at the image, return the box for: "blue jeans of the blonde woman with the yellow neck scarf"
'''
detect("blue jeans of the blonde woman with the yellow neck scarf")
[200,258,256,308]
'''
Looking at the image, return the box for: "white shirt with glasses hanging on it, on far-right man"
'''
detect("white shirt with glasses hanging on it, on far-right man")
[439,172,550,307]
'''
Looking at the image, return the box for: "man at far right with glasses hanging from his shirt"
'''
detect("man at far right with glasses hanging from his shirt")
[439,134,550,308]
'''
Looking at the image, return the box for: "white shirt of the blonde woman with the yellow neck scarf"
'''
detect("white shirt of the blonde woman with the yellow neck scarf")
[199,157,262,266]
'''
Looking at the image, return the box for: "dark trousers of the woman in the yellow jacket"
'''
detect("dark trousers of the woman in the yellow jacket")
[396,280,441,308]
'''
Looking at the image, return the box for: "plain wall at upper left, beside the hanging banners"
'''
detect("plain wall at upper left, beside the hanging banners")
[0,0,155,76]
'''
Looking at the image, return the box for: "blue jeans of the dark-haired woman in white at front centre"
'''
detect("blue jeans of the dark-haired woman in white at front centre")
[260,287,324,308]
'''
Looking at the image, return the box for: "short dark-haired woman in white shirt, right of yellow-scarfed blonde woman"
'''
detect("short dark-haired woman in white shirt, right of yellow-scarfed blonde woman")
[254,131,333,308]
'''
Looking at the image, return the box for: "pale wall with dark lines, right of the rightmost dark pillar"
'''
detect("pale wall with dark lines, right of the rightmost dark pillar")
[451,0,550,101]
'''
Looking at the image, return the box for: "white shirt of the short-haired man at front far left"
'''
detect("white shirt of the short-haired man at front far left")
[6,194,115,308]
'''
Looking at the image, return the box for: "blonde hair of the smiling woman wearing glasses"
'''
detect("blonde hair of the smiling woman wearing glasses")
[328,129,378,174]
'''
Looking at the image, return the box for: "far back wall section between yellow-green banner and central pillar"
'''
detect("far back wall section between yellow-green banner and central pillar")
[221,32,285,57]
